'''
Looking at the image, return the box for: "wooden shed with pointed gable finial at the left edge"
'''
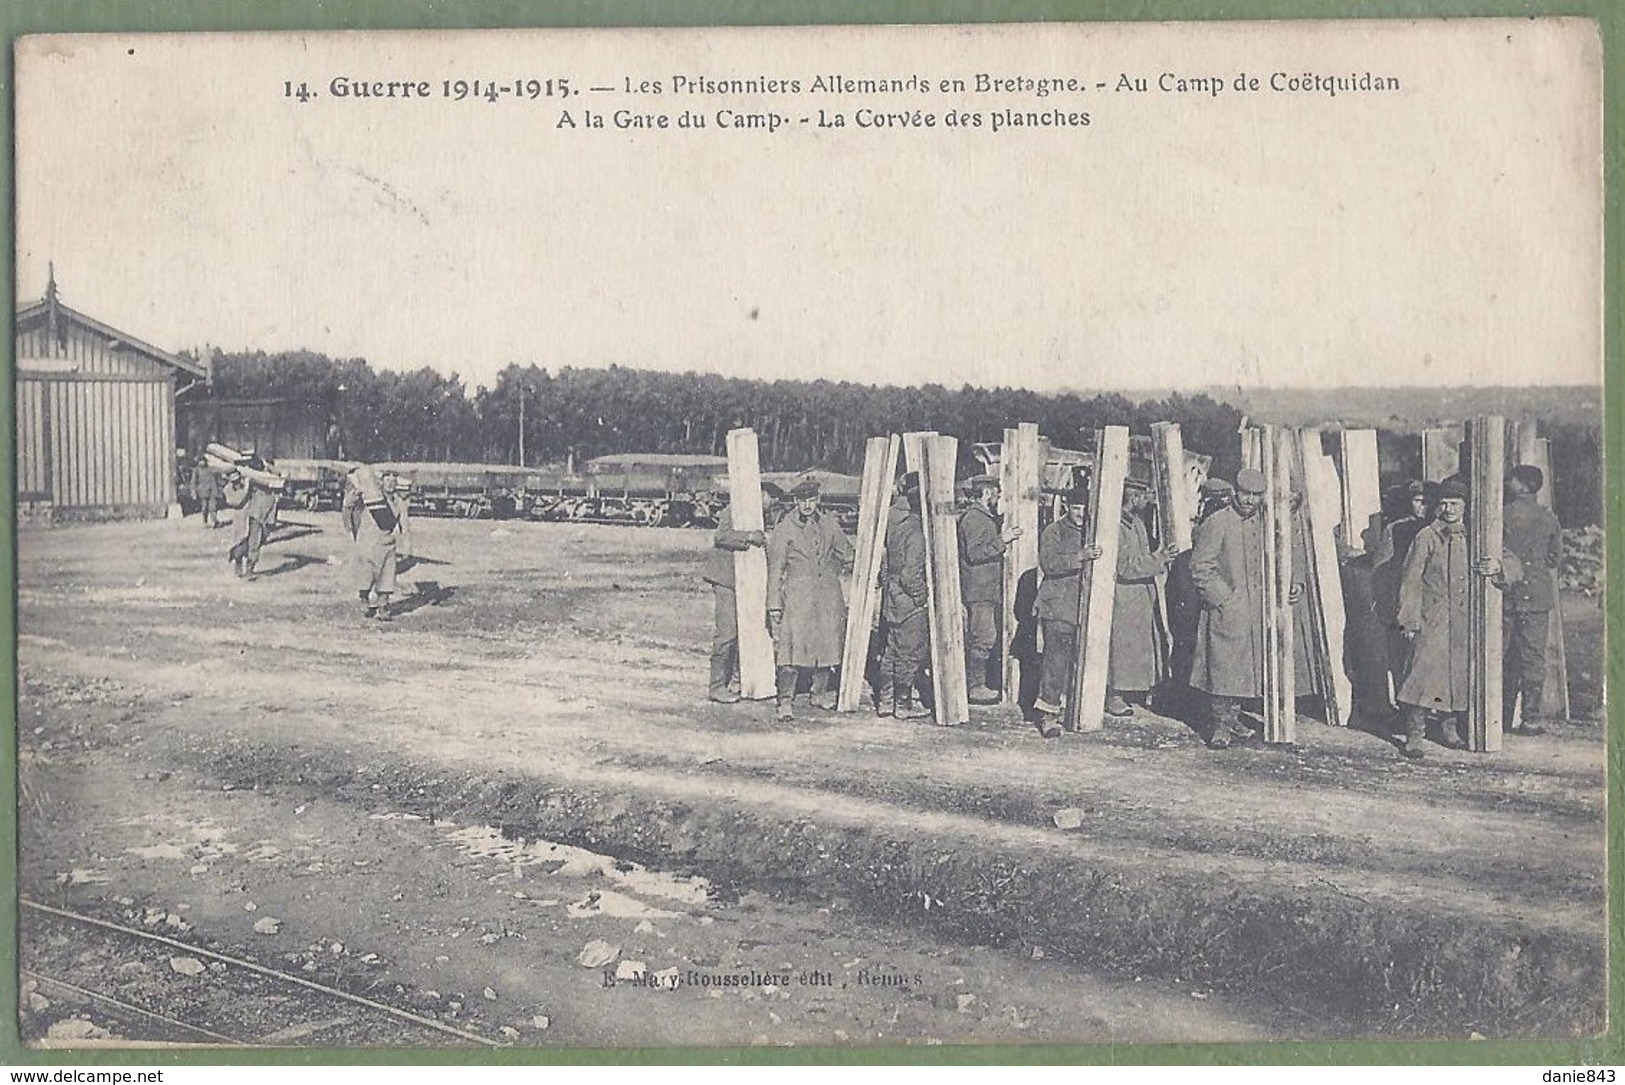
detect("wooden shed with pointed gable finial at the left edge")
[15,278,206,520]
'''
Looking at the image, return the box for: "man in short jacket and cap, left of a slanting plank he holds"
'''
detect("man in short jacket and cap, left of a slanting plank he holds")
[1032,484,1102,739]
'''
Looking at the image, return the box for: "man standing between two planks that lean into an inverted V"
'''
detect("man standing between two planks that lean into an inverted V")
[876,471,931,720]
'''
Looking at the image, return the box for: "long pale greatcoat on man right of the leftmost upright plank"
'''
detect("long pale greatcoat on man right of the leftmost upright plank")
[767,512,853,668]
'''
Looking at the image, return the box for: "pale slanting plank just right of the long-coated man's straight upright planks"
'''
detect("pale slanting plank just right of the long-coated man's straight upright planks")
[1292,429,1354,728]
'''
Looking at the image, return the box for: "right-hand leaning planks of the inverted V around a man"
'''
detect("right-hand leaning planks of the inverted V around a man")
[904,432,970,726]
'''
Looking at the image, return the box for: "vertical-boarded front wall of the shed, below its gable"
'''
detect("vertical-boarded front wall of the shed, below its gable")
[16,377,174,515]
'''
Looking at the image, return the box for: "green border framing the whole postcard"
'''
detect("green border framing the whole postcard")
[0,0,1625,1069]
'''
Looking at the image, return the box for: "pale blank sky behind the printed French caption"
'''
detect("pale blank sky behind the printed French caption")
[16,19,1602,391]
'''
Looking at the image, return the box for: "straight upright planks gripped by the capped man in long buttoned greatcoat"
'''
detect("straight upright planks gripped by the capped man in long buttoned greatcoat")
[1258,426,1298,742]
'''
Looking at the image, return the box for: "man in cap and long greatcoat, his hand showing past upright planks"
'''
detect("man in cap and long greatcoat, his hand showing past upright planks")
[1191,468,1303,749]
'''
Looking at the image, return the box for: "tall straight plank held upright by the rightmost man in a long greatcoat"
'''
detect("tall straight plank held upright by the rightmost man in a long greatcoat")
[1467,414,1506,754]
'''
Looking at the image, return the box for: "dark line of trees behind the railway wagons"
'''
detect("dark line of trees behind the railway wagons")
[196,351,1242,473]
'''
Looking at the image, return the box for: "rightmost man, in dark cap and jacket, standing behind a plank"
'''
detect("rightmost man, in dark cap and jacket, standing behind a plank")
[1502,463,1563,734]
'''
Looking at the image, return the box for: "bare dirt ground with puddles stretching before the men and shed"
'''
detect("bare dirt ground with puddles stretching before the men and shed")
[18,513,1606,1046]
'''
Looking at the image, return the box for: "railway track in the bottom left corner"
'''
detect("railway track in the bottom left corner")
[20,898,505,1048]
